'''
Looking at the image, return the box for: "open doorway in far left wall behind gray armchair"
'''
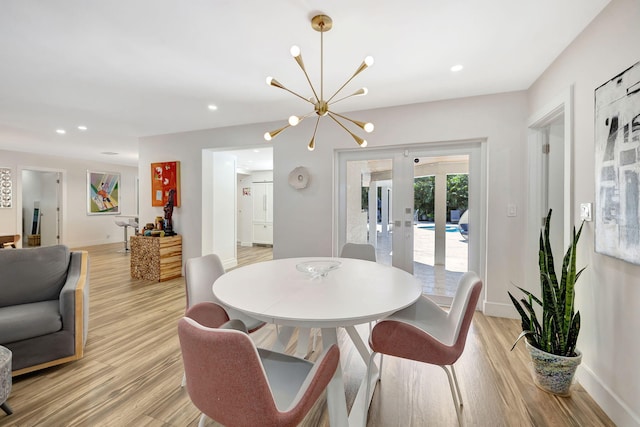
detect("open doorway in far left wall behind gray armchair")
[20,169,63,247]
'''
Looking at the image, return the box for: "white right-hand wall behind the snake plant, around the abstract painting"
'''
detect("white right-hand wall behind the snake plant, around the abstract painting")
[529,0,640,426]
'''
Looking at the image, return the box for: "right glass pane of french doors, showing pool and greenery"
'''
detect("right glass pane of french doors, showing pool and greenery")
[413,155,469,299]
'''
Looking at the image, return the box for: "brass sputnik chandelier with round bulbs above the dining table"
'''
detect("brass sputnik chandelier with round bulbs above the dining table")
[264,15,373,151]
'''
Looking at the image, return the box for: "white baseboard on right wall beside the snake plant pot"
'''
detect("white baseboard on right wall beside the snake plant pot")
[576,363,640,427]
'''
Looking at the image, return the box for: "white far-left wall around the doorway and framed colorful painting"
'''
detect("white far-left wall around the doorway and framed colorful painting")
[0,150,138,247]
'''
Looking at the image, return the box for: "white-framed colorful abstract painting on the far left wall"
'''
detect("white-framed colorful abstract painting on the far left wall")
[87,171,120,215]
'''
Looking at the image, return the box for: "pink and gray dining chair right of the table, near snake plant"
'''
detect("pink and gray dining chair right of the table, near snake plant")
[365,271,482,425]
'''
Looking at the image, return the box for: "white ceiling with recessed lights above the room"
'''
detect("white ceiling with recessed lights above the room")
[0,0,609,165]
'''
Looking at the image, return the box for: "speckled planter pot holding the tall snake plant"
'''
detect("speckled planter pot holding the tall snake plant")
[525,340,582,396]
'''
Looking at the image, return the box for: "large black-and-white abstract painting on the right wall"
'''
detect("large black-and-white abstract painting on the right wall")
[595,62,640,264]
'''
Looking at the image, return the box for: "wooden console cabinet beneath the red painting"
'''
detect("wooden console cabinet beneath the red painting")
[129,235,182,282]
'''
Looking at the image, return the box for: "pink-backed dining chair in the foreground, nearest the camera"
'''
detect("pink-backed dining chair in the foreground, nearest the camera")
[178,317,340,427]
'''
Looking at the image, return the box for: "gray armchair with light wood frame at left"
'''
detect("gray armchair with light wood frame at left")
[0,245,89,376]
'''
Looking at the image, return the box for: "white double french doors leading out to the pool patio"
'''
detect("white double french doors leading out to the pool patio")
[334,141,486,304]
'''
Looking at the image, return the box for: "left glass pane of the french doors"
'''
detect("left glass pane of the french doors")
[346,159,393,265]
